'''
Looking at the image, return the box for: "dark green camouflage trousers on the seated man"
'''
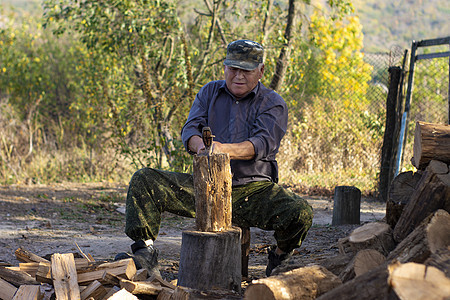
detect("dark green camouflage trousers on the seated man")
[125,168,313,251]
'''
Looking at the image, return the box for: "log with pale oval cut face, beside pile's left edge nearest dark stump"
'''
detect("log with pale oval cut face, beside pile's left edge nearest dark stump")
[338,222,395,255]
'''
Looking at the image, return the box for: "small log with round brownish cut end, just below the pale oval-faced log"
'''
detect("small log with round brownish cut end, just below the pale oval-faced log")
[339,249,386,282]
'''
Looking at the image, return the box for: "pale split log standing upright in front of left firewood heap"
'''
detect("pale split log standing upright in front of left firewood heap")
[51,253,80,300]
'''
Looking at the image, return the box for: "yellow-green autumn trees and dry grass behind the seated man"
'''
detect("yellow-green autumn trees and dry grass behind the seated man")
[0,0,448,197]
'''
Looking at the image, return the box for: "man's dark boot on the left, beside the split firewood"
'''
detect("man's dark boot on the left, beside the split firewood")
[114,240,161,276]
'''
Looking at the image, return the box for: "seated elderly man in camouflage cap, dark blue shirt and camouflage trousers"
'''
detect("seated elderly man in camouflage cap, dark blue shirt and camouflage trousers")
[116,40,313,276]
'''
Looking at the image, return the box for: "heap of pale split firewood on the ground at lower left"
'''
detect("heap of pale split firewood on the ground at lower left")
[0,248,241,300]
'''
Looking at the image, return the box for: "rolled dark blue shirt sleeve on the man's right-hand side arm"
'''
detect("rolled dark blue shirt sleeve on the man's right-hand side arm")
[249,93,288,160]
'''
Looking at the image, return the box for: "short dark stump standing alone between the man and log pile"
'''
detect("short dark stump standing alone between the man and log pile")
[331,186,361,226]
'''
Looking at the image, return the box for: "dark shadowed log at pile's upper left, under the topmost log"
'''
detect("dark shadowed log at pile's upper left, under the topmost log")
[386,171,422,228]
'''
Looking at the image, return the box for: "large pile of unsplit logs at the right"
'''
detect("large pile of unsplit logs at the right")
[245,122,450,300]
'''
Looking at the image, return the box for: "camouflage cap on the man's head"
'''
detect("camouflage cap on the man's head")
[223,40,264,71]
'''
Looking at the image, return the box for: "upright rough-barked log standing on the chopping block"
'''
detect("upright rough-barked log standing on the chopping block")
[193,153,231,232]
